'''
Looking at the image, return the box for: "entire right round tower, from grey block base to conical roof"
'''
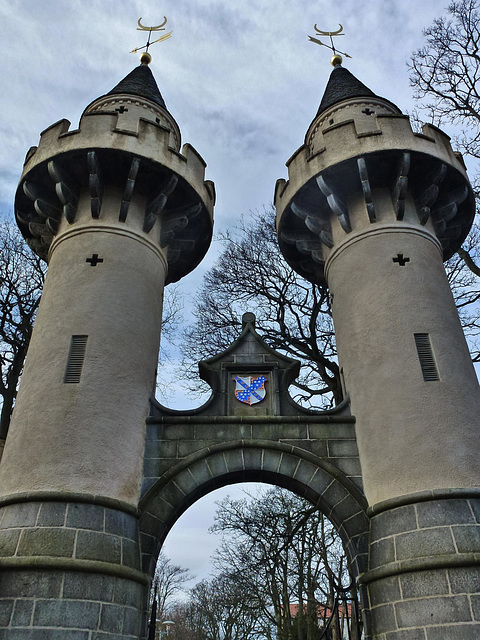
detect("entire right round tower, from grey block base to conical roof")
[275,58,480,640]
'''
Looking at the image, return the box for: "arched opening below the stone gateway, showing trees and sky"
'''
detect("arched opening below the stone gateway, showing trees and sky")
[156,482,360,640]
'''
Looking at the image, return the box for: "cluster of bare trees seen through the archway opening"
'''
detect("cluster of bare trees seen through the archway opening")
[208,488,349,640]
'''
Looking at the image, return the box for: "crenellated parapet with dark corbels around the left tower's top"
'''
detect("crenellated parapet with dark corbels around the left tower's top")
[15,109,215,282]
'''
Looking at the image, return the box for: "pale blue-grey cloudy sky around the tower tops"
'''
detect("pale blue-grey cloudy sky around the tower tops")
[0,0,458,592]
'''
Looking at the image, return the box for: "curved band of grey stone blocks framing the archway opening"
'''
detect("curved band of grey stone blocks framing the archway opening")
[139,440,369,577]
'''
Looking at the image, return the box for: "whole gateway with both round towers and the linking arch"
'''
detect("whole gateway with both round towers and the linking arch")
[0,46,480,640]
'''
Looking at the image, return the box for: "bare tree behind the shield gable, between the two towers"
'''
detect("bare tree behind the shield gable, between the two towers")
[182,210,342,405]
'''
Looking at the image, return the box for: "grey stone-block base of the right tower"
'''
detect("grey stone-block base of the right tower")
[362,492,480,640]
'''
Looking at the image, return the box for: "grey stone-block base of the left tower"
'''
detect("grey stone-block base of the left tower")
[0,501,147,640]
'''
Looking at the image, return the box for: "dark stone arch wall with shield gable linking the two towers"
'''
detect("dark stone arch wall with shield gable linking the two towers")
[139,313,369,576]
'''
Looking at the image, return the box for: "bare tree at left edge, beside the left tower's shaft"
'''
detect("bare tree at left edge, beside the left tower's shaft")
[0,222,46,440]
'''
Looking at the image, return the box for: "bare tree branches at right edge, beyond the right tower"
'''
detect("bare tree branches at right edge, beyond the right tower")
[409,0,480,348]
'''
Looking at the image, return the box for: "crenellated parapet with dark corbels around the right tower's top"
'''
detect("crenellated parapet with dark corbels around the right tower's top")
[274,111,474,279]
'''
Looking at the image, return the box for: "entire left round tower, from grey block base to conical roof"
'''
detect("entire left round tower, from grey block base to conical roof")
[0,58,215,638]
